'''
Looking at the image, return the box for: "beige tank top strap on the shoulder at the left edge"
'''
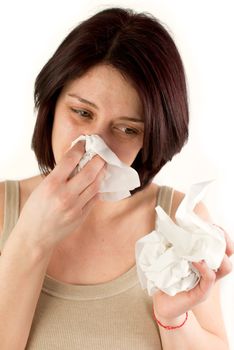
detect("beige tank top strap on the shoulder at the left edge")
[0,180,19,250]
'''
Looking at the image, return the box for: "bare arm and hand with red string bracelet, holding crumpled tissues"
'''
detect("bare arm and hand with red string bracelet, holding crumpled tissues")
[153,192,233,350]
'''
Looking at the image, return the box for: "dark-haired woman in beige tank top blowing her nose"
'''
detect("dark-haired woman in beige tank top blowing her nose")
[0,9,233,350]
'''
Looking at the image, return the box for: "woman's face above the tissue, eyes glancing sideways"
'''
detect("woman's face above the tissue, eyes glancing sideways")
[52,65,144,165]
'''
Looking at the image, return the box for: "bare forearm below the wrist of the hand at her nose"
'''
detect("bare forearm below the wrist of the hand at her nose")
[0,230,52,350]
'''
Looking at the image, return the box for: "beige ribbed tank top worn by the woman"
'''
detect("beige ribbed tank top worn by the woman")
[0,181,173,350]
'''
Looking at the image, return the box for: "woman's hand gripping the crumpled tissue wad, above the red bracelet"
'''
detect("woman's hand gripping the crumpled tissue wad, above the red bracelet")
[153,227,234,324]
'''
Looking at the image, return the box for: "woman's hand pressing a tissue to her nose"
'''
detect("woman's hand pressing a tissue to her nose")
[15,142,105,250]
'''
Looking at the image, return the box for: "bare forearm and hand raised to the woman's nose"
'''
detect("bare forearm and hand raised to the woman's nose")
[0,141,104,350]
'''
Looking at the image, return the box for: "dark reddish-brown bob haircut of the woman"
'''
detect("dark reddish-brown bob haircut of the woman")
[32,8,188,193]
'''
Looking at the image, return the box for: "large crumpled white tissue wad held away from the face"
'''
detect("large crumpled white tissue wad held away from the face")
[136,181,226,296]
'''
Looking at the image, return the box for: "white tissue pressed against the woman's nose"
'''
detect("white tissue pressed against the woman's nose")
[71,135,140,201]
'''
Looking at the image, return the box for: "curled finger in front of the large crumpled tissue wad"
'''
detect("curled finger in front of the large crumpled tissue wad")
[188,260,216,302]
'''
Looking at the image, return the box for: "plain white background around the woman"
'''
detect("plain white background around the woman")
[0,0,234,349]
